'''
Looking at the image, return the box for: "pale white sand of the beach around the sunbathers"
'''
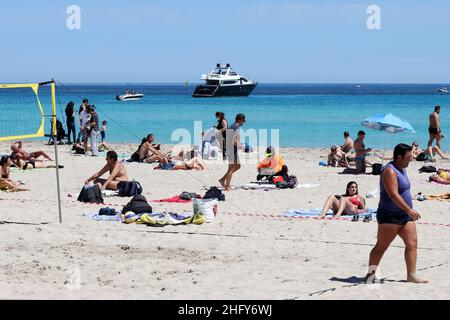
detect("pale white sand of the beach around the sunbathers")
[0,141,450,300]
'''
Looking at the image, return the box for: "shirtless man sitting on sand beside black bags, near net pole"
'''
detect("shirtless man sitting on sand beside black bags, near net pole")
[84,151,129,190]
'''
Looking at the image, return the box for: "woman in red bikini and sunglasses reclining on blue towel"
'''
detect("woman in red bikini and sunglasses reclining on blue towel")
[319,181,366,218]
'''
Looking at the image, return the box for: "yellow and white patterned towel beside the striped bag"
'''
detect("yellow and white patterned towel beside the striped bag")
[136,211,205,227]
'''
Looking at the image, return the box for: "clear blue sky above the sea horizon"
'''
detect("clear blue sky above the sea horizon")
[0,0,450,83]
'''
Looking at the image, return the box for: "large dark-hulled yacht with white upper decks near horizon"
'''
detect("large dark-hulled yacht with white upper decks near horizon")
[192,63,258,97]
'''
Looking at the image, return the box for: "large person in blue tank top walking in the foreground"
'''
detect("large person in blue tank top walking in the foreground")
[366,143,428,283]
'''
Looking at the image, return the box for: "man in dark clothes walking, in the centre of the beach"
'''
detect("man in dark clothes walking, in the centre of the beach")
[219,113,245,191]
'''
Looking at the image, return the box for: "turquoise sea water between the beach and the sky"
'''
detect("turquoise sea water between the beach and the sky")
[0,84,450,151]
